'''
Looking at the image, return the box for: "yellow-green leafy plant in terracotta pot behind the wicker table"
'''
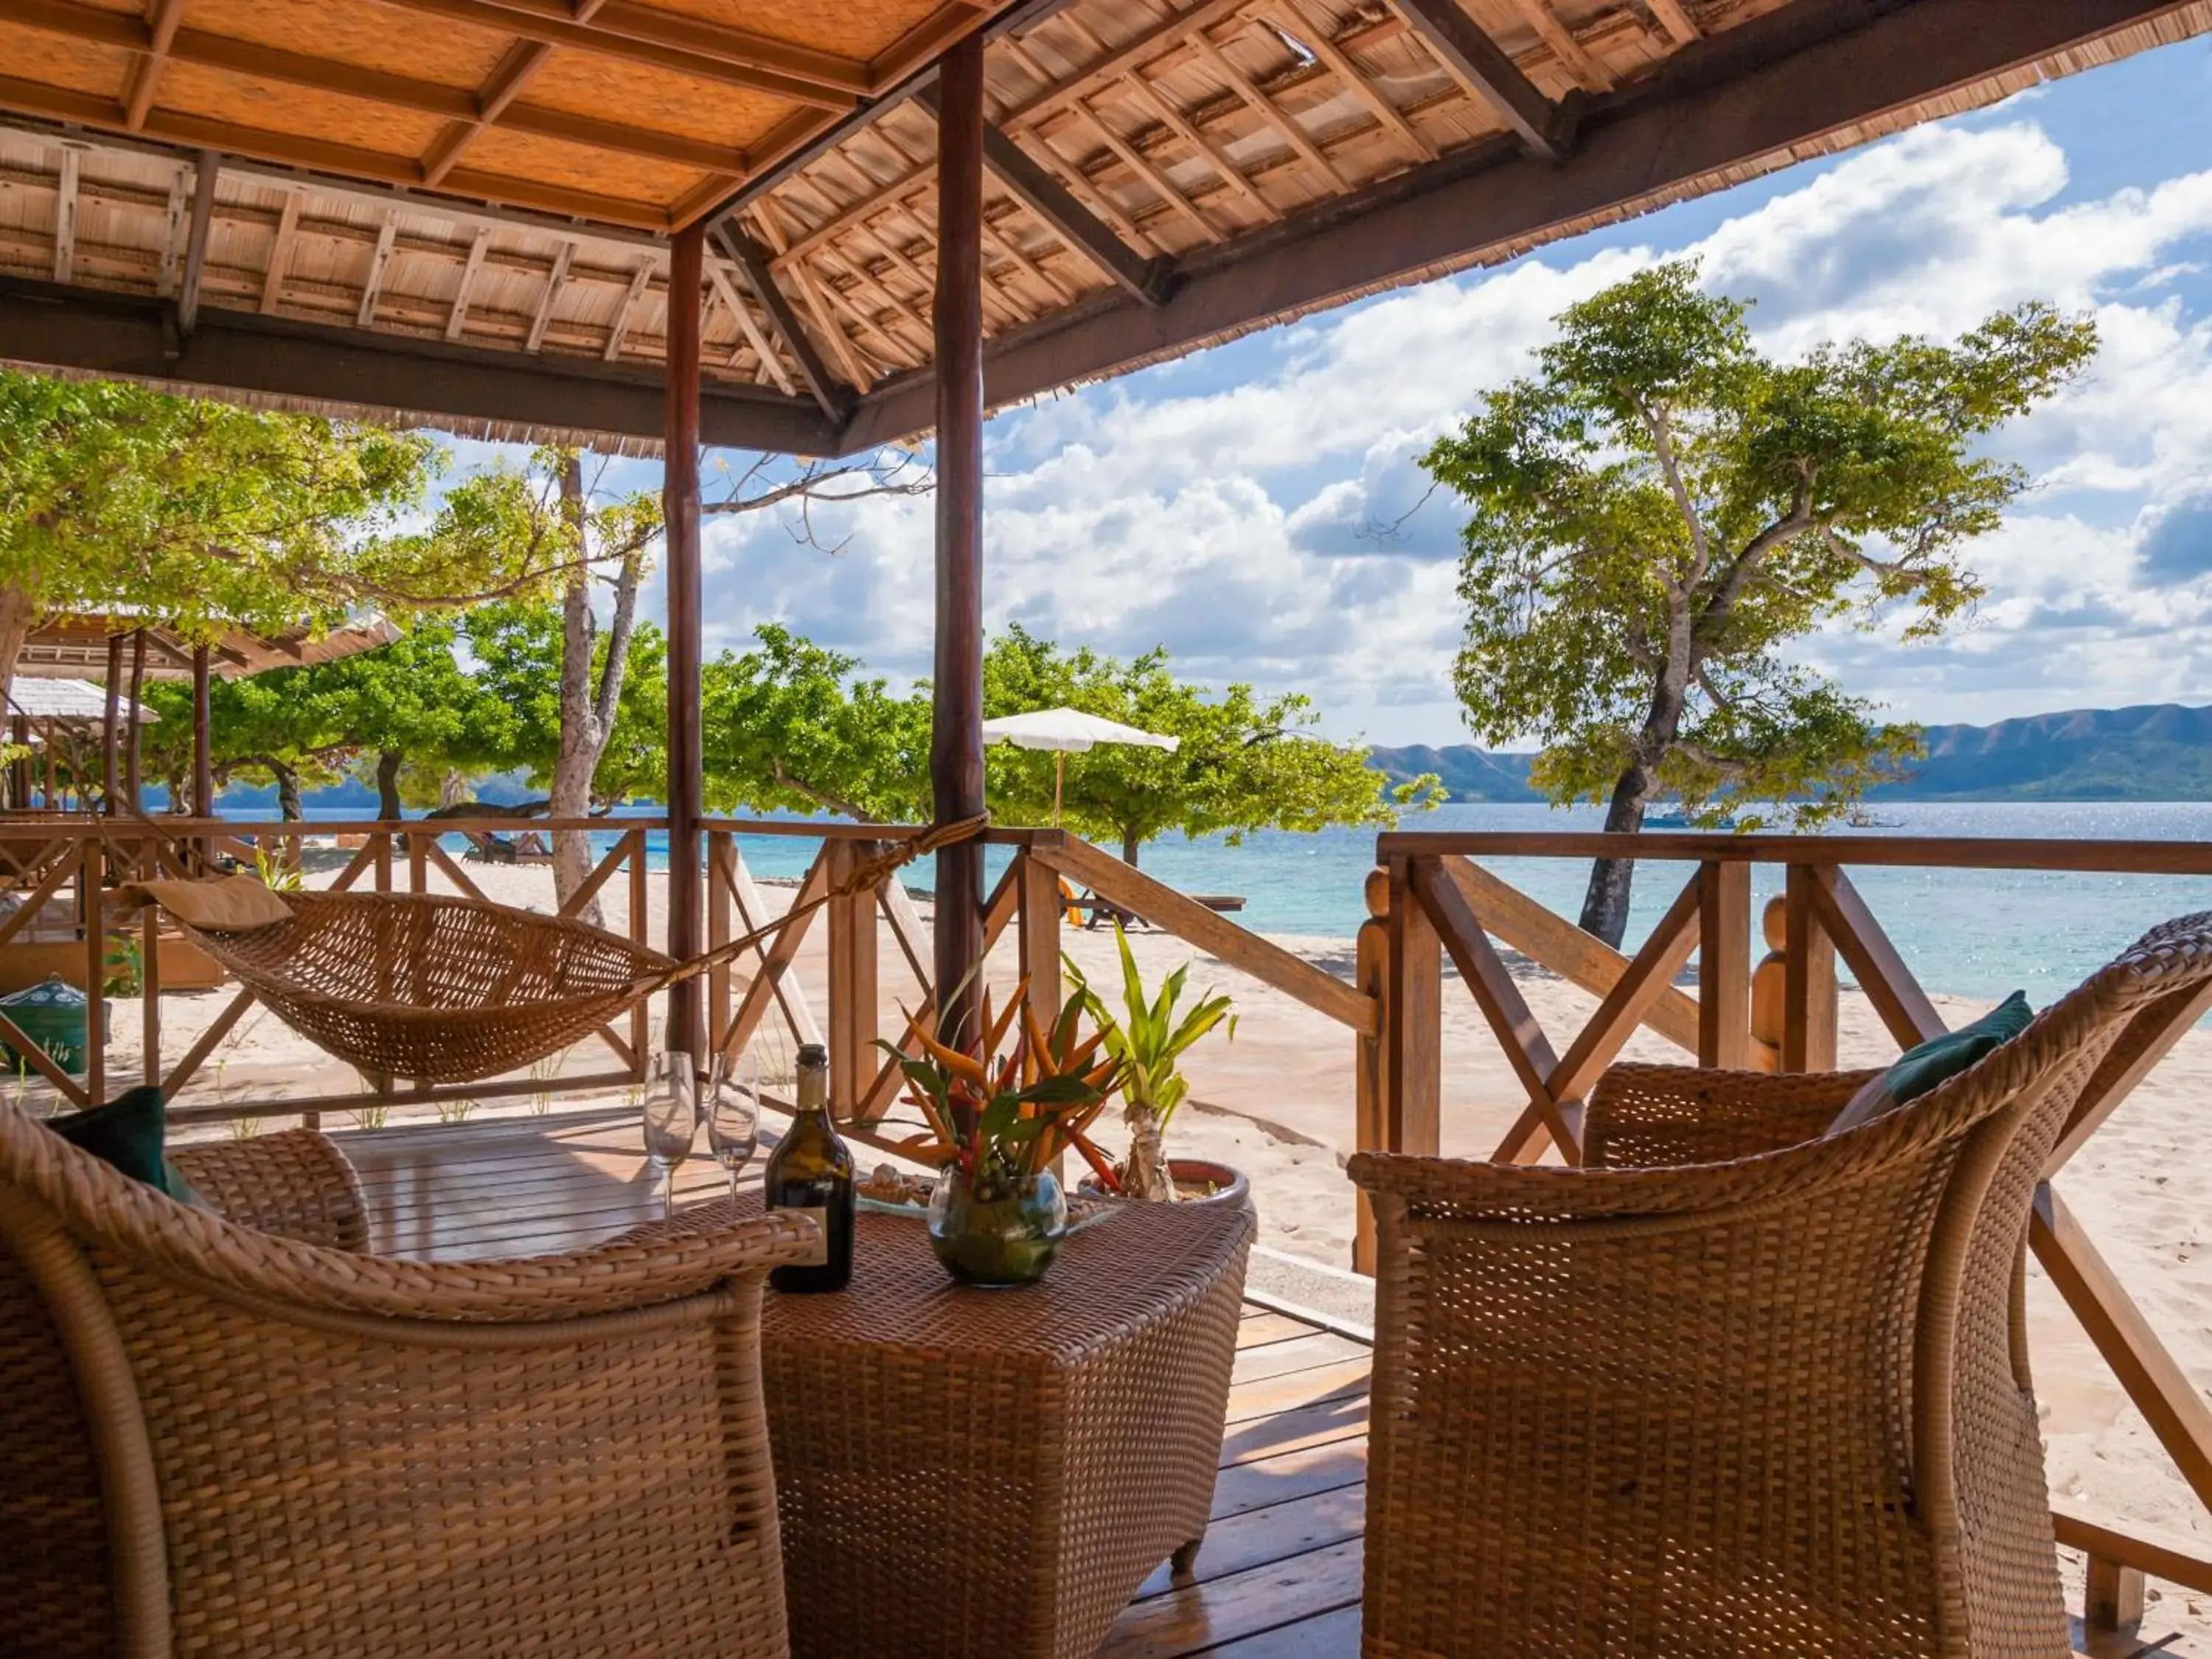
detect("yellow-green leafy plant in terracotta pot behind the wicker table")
[1068,922,1250,1203]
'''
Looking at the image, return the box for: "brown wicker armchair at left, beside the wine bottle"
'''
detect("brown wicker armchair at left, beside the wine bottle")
[0,1106,805,1659]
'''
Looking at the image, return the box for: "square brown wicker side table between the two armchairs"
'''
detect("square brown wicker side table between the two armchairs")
[726,1203,1254,1659]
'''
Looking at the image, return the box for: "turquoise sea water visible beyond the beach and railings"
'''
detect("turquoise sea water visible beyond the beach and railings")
[285,801,2212,1004]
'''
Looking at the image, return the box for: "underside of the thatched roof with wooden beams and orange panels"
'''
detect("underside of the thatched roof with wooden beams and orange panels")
[0,0,2212,453]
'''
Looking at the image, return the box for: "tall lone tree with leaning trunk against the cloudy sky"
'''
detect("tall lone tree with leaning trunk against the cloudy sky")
[1422,261,2097,945]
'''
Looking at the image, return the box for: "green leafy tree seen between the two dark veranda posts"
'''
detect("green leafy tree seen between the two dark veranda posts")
[701,624,929,823]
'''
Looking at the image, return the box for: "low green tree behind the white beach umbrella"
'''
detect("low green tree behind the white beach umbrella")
[982,624,1442,863]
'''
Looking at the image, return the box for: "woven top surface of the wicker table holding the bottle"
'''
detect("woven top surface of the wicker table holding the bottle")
[692,1194,1254,1363]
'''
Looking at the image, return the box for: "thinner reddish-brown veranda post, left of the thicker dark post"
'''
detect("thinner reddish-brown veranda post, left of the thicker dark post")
[661,223,706,1060]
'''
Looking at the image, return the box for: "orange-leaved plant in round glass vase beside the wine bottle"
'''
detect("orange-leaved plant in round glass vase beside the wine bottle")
[880,980,1121,1285]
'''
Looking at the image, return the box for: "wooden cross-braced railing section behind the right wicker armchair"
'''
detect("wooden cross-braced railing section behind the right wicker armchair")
[1354,834,2212,1632]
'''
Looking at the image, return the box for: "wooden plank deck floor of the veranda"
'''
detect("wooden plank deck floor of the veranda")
[336,1110,1367,1659]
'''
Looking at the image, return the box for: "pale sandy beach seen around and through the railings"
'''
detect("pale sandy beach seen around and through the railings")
[69,865,2212,1639]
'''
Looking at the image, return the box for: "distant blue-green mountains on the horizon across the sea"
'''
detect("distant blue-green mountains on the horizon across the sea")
[1369,703,2212,801]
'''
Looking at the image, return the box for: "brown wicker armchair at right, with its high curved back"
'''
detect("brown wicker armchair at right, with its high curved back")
[1352,916,2212,1659]
